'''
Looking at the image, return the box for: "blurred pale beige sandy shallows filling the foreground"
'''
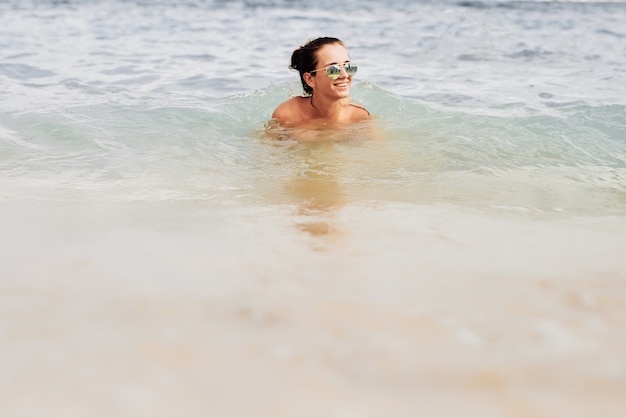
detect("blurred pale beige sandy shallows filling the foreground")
[0,200,626,418]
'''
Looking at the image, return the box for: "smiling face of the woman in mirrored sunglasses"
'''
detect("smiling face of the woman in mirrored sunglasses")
[305,44,352,99]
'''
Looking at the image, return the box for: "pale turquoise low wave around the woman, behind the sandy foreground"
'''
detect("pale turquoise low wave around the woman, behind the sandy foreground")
[1,82,626,215]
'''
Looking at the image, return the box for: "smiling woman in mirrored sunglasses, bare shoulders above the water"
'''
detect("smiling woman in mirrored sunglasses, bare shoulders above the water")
[272,37,370,128]
